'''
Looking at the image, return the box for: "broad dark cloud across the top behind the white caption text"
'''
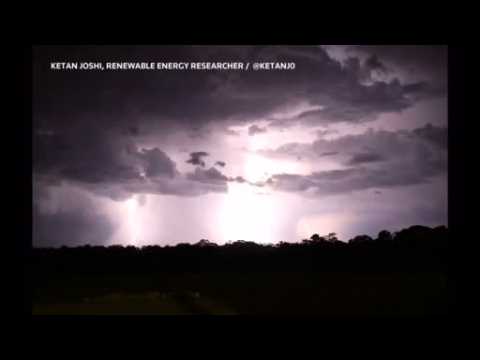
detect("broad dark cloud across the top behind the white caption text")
[33,46,446,136]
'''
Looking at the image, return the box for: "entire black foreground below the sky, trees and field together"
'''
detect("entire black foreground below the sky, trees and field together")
[30,228,453,317]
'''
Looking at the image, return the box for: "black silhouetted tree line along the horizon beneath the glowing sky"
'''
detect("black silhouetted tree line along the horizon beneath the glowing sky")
[30,225,448,276]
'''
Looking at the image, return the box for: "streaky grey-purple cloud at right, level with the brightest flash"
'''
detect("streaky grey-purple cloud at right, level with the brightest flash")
[262,125,447,195]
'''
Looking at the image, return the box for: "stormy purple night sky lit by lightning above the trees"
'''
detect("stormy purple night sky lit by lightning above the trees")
[32,45,448,246]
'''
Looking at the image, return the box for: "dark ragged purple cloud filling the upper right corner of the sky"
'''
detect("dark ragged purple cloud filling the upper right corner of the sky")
[272,46,447,126]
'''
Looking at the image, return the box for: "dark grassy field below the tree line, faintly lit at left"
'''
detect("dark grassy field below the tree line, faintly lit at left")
[32,272,448,317]
